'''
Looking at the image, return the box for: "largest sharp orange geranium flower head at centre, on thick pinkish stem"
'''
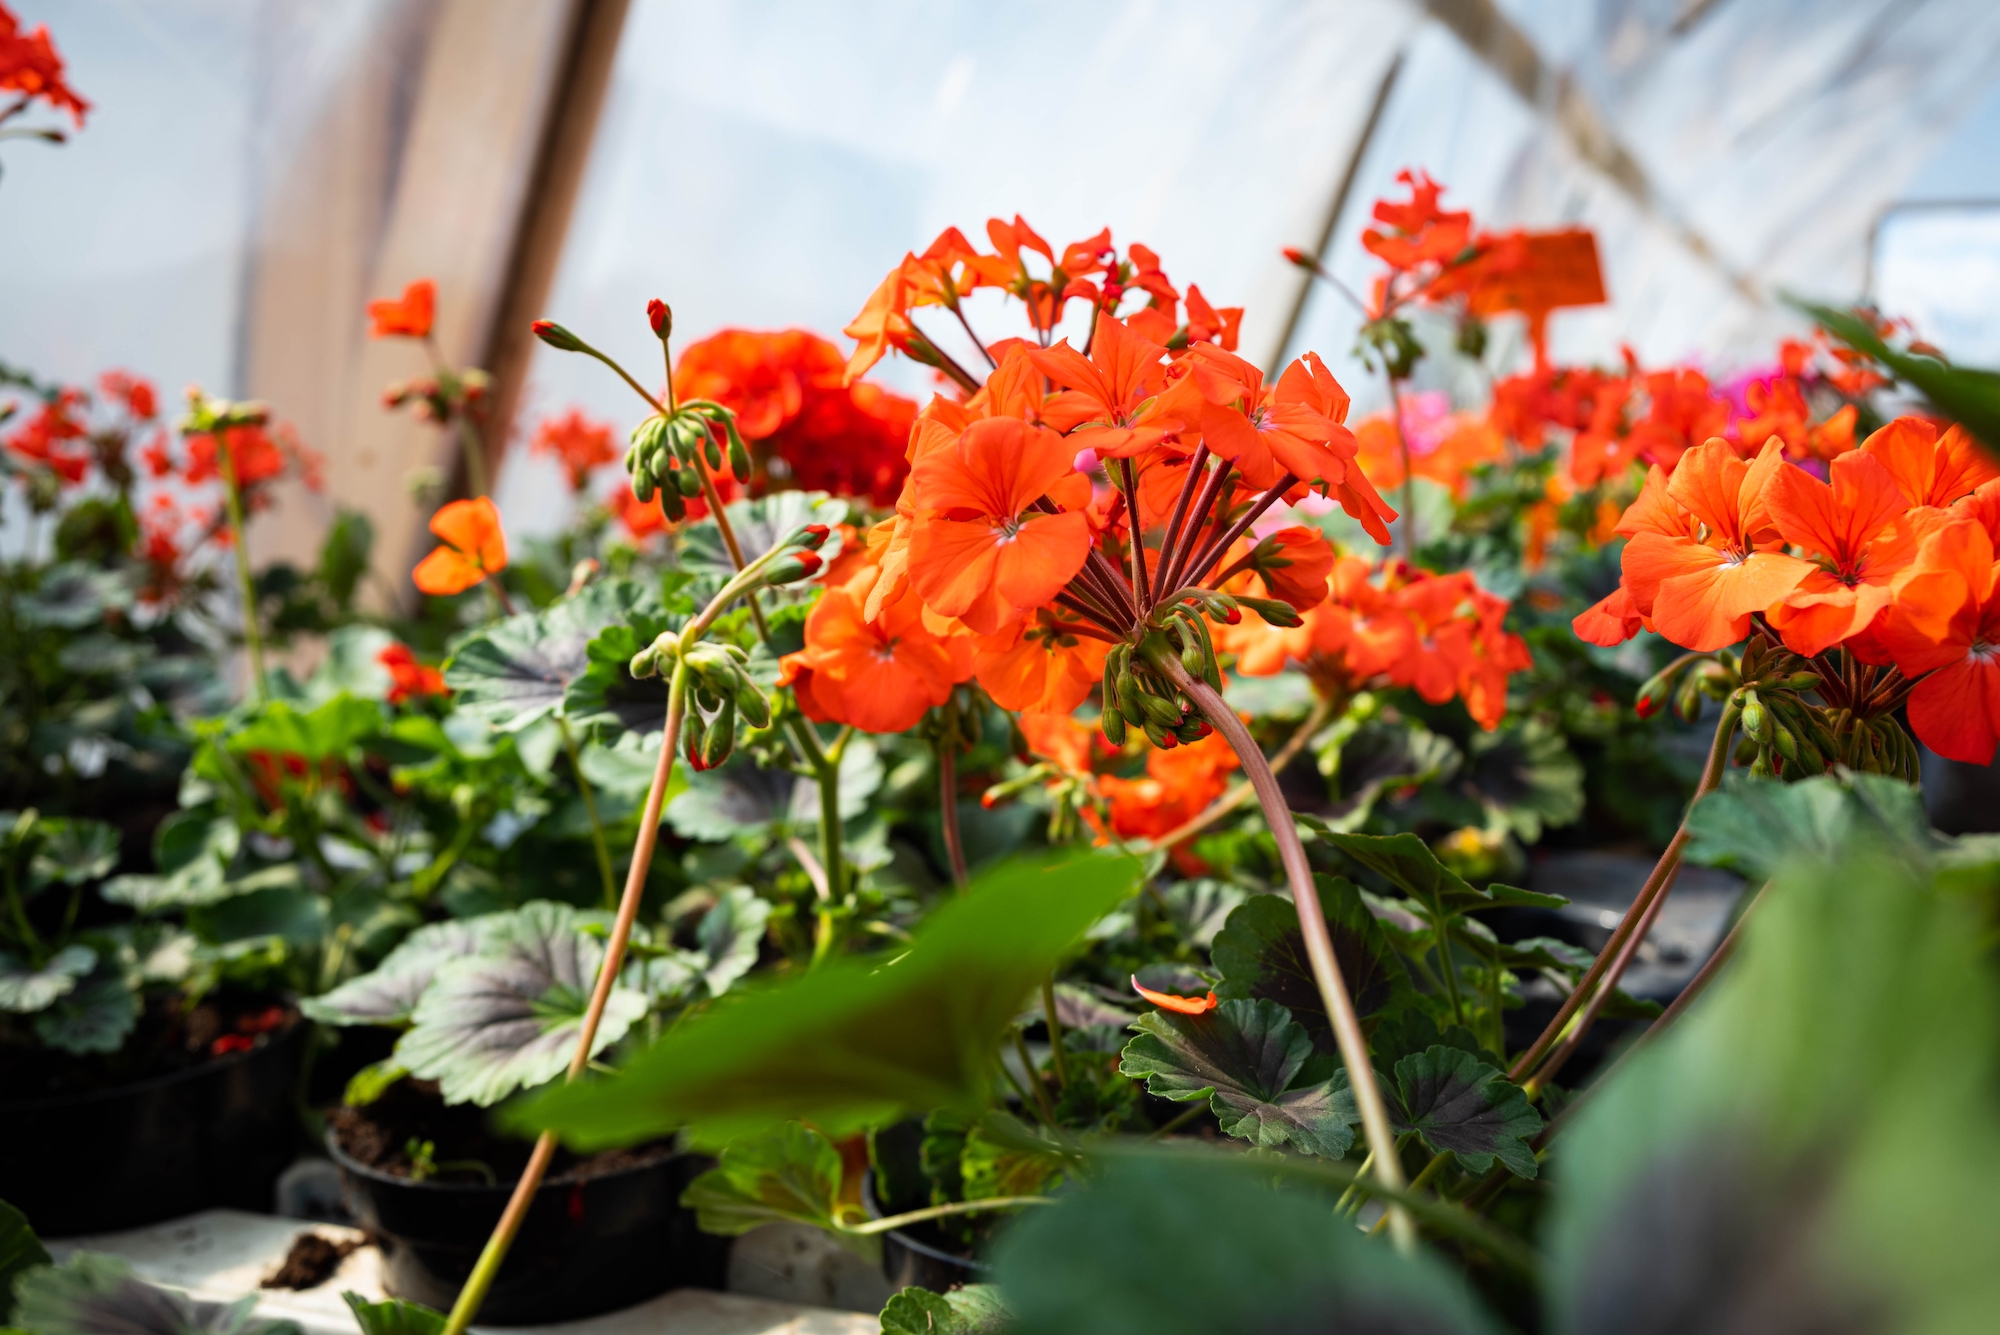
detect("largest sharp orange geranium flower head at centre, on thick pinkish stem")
[786,218,1396,745]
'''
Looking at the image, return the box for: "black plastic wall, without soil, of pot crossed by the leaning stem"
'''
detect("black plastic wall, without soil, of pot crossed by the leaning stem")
[326,1135,728,1325]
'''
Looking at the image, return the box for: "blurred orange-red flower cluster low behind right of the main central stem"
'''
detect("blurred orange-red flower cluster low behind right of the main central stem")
[1216,556,1534,731]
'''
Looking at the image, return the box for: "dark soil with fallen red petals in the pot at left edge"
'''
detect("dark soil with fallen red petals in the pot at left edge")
[0,989,302,1101]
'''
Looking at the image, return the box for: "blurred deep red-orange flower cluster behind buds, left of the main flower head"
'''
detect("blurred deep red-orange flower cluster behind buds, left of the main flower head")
[674,330,916,506]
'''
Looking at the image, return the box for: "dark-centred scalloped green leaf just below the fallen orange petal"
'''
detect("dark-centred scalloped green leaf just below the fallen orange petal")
[1118,1001,1354,1159]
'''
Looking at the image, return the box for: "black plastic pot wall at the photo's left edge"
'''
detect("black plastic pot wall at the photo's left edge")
[0,1021,312,1237]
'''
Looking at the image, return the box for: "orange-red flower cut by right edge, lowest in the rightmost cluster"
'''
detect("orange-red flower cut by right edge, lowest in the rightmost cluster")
[1882,522,2000,765]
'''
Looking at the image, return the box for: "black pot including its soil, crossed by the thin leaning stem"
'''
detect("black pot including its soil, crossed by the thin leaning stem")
[328,1081,728,1325]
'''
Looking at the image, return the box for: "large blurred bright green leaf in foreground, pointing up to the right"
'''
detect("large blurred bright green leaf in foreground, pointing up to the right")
[512,855,1138,1147]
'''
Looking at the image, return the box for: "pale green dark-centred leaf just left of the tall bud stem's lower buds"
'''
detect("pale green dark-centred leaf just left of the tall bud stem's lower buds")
[444,580,660,731]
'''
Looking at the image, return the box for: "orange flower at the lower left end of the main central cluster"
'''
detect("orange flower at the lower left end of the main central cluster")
[778,566,972,731]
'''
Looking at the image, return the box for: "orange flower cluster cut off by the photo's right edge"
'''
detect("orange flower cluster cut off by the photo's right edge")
[1574,418,2000,763]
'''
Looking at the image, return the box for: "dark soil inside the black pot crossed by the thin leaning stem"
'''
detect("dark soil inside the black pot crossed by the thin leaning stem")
[326,1079,674,1185]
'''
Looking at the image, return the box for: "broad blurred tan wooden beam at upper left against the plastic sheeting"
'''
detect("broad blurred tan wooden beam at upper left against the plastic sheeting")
[242,0,616,604]
